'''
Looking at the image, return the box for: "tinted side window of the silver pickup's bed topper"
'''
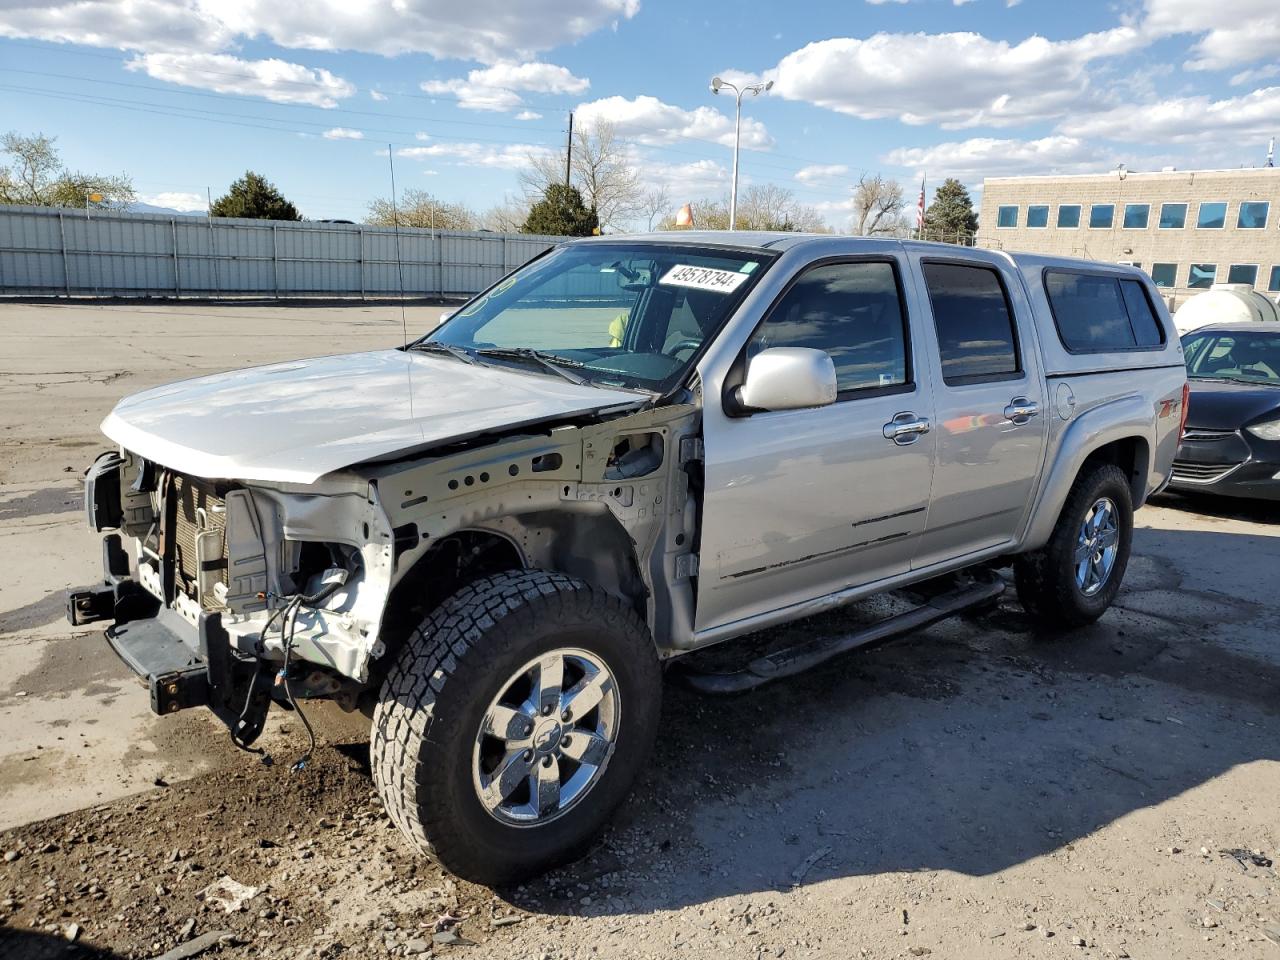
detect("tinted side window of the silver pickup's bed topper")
[1044,270,1165,353]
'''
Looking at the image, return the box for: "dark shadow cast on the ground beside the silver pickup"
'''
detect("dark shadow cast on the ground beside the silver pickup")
[516,522,1280,914]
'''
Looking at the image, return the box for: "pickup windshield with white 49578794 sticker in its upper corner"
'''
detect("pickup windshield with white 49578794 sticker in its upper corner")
[416,243,776,393]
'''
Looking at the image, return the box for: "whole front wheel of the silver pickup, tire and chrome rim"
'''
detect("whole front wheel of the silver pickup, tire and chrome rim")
[370,571,662,883]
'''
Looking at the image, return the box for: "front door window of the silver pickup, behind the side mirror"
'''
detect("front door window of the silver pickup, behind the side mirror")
[746,261,911,399]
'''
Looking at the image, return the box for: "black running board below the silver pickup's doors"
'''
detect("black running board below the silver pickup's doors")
[671,573,1005,694]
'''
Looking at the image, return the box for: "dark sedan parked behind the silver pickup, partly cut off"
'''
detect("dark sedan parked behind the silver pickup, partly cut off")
[1169,323,1280,499]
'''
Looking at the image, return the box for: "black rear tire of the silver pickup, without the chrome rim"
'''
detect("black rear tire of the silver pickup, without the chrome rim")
[1014,463,1133,630]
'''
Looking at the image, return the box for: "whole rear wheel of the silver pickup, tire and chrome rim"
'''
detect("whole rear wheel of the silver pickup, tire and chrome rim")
[1014,463,1133,627]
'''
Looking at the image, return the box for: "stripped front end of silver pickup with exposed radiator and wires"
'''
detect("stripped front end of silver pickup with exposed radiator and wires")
[67,452,394,745]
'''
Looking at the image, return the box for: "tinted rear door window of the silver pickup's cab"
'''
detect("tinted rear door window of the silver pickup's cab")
[922,261,1021,387]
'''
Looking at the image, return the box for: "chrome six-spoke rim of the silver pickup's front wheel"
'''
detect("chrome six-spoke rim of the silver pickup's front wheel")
[471,649,622,827]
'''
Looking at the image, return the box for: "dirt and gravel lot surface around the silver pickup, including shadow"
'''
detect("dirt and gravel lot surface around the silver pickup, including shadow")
[0,307,1280,960]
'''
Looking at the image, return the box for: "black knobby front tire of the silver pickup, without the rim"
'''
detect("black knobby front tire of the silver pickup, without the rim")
[370,571,662,884]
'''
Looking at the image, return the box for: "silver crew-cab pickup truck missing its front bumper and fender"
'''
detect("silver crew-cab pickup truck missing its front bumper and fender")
[68,233,1187,882]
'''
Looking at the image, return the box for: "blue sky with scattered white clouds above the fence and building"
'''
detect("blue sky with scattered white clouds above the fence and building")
[0,0,1280,229]
